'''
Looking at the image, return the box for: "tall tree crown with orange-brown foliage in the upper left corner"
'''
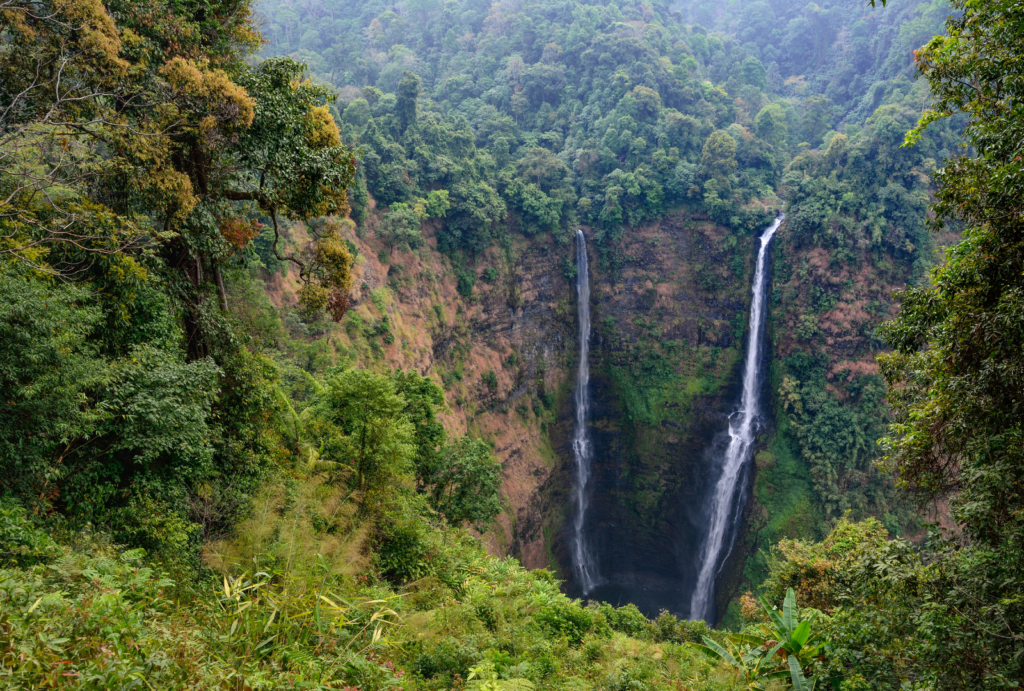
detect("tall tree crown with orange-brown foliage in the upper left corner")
[0,0,355,357]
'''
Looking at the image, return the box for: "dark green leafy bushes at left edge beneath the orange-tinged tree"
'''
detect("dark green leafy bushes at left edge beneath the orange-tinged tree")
[0,271,256,551]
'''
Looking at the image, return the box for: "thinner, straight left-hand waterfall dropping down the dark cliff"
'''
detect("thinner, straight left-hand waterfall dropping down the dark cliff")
[572,229,600,595]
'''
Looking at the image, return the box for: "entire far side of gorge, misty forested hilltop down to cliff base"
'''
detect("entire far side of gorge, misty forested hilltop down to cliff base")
[243,0,954,621]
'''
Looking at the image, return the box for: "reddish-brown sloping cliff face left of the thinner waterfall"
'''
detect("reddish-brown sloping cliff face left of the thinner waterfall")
[268,220,577,568]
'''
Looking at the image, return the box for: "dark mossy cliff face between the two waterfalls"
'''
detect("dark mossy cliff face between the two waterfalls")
[547,214,770,615]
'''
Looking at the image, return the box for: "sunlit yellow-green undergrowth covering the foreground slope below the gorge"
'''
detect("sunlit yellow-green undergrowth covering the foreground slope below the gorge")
[0,489,753,691]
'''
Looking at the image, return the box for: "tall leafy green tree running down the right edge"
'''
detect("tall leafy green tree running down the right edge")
[851,0,1024,688]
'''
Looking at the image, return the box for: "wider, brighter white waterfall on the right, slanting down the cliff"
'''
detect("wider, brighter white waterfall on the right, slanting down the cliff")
[690,214,785,619]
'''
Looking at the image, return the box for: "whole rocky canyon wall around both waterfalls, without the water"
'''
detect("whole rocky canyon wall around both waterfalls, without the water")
[268,197,921,615]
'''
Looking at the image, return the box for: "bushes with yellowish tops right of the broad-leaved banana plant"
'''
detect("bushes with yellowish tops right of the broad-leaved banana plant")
[769,522,1014,689]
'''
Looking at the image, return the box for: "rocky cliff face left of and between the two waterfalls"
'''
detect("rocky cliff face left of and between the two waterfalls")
[270,213,767,614]
